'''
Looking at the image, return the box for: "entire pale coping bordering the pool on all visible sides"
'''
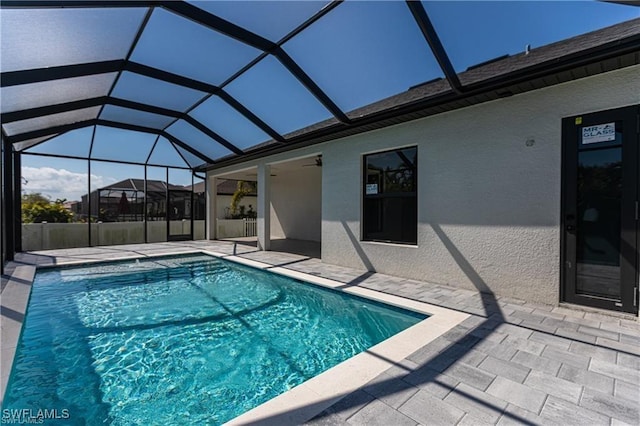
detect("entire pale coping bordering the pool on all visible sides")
[0,249,470,426]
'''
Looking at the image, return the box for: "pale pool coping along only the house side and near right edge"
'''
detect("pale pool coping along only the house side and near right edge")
[215,250,471,426]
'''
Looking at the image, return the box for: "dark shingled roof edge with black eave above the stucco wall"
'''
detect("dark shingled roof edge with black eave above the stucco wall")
[209,18,640,169]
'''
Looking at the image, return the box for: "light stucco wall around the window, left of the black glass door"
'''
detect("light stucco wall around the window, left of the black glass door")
[212,66,640,304]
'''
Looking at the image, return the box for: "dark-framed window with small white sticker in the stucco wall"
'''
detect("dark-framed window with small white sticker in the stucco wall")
[362,147,418,244]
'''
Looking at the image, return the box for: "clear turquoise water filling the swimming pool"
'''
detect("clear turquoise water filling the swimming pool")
[3,254,425,425]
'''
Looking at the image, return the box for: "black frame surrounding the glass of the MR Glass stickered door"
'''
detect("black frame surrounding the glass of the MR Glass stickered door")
[560,105,640,314]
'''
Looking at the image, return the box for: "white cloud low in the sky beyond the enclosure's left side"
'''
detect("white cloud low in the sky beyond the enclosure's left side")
[22,166,116,201]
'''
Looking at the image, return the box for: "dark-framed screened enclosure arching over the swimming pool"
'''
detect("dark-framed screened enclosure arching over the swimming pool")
[0,0,637,272]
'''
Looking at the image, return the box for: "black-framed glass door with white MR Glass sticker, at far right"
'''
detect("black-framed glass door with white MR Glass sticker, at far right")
[561,106,639,313]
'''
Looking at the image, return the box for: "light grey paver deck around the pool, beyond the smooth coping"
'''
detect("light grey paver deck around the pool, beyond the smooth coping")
[2,241,640,426]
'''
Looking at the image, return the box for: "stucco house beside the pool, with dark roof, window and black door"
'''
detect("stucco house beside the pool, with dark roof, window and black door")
[208,19,640,313]
